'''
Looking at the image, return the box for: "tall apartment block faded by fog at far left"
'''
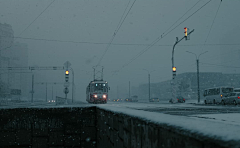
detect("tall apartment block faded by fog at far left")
[1,42,28,96]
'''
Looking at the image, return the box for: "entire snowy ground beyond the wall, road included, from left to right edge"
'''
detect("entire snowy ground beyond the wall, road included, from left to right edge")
[0,98,240,141]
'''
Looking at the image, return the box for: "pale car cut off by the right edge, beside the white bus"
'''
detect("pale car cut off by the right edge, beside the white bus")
[222,92,240,105]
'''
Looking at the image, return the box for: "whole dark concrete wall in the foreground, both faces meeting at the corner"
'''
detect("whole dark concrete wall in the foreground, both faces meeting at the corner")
[0,107,239,148]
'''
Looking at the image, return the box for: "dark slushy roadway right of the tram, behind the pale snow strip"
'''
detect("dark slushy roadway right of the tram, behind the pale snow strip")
[108,101,240,116]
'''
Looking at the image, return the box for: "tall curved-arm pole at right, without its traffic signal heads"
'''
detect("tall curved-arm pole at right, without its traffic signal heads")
[170,29,194,103]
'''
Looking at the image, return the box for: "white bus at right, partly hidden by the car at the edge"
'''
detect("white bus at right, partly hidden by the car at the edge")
[203,87,233,104]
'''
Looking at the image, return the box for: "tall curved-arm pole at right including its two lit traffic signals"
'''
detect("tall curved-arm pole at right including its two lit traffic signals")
[170,27,194,103]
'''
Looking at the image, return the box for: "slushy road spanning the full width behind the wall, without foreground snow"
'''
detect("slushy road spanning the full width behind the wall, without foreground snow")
[0,100,240,116]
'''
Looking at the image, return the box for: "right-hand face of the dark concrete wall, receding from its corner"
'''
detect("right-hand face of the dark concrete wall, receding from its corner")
[97,109,239,148]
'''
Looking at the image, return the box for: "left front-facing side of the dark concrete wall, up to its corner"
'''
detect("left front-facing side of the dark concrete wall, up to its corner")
[0,107,97,148]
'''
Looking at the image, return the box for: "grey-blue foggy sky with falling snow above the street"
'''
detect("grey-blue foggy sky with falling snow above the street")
[0,0,240,100]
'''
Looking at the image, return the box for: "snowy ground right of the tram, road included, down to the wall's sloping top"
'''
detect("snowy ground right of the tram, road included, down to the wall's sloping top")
[99,102,240,141]
